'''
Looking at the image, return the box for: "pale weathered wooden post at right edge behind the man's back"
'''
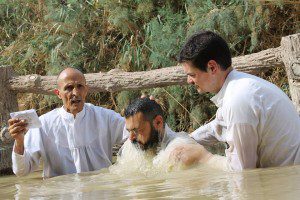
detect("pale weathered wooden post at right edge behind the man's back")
[281,33,300,114]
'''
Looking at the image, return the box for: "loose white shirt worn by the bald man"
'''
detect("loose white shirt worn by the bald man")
[12,103,128,177]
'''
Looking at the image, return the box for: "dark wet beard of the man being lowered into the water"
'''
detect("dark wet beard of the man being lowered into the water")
[132,126,161,152]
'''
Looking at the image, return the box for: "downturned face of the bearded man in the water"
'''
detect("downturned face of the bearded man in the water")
[125,112,159,150]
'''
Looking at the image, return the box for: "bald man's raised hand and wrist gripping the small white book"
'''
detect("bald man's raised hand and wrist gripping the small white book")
[8,118,27,155]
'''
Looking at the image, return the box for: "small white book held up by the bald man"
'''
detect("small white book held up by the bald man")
[10,109,42,128]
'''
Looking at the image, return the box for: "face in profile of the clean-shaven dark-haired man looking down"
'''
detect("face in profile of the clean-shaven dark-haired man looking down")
[182,62,213,94]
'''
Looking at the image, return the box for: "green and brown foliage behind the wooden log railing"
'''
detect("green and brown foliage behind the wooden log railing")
[0,0,300,141]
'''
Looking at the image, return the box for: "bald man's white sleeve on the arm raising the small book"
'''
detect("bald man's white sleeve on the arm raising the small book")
[12,128,41,176]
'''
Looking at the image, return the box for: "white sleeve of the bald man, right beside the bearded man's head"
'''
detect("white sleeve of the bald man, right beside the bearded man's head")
[109,111,129,145]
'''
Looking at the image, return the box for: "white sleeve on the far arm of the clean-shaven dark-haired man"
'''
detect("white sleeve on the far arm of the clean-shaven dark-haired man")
[190,119,221,146]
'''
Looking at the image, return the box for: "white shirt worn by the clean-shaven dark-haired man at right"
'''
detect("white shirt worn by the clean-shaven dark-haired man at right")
[191,70,300,170]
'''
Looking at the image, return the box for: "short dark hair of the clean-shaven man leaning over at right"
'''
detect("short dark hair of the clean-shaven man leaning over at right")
[178,30,232,71]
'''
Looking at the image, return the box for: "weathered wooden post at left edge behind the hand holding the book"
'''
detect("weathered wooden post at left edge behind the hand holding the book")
[0,66,18,174]
